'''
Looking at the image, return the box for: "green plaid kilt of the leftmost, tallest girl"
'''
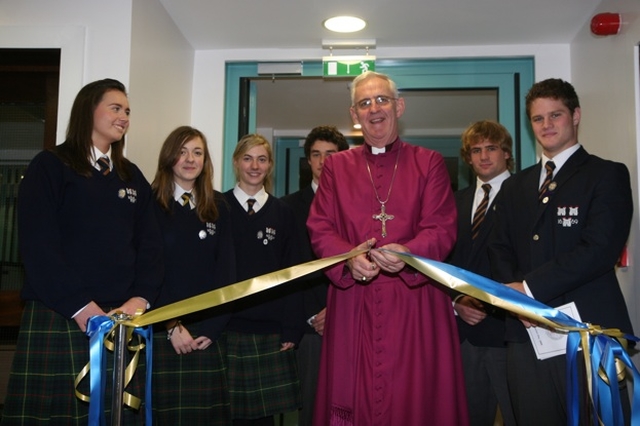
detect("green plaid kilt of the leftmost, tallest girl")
[1,301,146,426]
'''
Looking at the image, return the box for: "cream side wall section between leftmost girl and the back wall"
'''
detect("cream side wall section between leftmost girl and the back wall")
[127,0,195,178]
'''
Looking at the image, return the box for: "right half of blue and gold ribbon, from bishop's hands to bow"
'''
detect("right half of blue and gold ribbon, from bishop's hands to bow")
[385,250,640,426]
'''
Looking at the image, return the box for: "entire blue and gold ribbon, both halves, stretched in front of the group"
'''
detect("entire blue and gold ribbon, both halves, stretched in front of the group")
[82,250,640,426]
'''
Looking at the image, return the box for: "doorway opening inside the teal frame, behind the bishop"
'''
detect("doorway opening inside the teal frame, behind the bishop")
[262,81,498,197]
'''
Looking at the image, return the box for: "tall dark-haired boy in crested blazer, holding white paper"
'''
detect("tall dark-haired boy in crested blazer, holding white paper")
[491,79,633,425]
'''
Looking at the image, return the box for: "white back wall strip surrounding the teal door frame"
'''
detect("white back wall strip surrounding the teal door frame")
[191,44,571,190]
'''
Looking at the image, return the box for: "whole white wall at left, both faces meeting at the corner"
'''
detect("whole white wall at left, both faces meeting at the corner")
[0,0,194,180]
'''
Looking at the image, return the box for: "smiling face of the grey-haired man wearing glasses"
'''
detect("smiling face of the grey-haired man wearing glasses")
[350,76,404,148]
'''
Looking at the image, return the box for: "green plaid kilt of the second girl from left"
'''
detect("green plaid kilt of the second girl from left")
[152,324,231,426]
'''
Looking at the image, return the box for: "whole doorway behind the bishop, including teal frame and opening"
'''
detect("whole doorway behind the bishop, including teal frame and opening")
[223,58,535,196]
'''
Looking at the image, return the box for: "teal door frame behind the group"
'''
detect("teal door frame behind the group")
[222,57,536,191]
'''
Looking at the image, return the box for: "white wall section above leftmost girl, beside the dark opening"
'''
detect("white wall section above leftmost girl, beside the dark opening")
[0,0,132,143]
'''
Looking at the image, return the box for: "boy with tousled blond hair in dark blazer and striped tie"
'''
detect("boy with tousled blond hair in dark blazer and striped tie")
[447,120,515,426]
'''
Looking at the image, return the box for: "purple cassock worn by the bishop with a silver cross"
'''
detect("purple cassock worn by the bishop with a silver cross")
[307,139,468,426]
